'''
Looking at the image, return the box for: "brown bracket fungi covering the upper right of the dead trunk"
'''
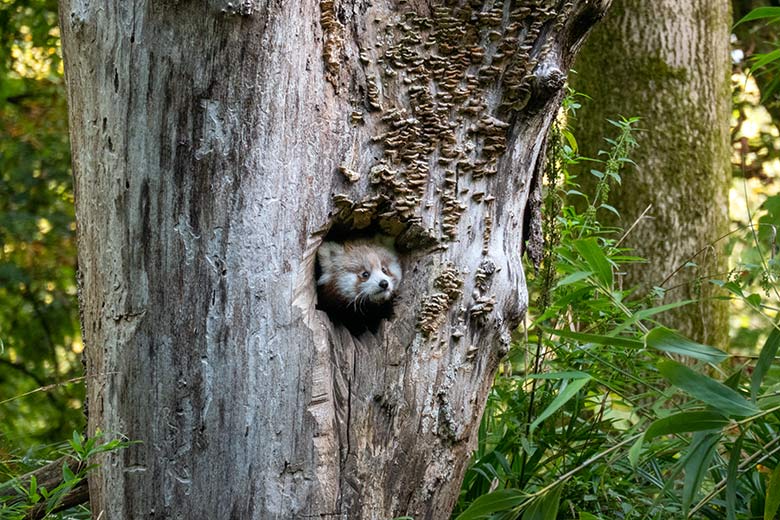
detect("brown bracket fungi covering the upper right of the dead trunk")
[320,0,573,336]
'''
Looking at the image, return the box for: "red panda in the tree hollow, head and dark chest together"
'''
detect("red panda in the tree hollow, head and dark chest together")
[317,240,402,335]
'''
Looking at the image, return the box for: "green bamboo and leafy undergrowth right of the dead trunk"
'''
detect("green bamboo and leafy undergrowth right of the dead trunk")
[455,91,780,520]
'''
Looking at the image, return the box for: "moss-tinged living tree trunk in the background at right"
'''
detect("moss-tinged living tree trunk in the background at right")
[572,0,731,346]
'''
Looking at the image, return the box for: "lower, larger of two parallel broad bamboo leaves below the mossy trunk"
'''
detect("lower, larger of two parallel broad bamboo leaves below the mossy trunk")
[658,360,759,417]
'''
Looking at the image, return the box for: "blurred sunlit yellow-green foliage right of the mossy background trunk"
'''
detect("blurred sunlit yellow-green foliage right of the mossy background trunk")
[722,2,780,353]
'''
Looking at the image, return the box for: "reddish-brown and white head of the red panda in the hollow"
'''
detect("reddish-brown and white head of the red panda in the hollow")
[317,241,402,310]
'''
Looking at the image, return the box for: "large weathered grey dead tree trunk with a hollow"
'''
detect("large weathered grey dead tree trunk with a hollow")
[60,0,609,519]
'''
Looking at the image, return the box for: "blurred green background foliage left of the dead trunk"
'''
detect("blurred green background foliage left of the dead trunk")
[0,0,83,457]
